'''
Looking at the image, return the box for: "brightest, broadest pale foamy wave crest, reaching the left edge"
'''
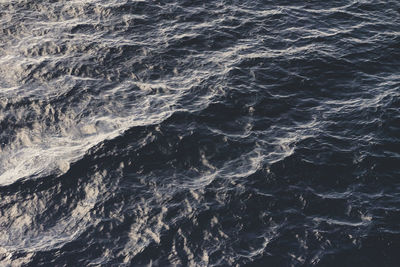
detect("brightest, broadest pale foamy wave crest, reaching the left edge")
[0,78,184,185]
